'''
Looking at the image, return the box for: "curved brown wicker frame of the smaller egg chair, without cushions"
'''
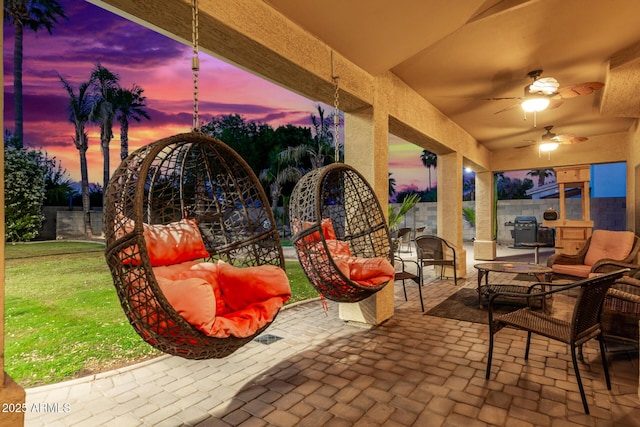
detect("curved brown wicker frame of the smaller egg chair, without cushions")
[289,163,393,302]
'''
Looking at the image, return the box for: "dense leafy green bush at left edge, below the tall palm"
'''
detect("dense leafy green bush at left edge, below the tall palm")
[4,144,45,242]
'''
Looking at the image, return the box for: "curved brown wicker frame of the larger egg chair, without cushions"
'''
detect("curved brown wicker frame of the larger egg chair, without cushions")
[104,132,284,359]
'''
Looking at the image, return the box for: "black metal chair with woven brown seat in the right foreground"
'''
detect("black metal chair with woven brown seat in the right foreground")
[486,269,628,414]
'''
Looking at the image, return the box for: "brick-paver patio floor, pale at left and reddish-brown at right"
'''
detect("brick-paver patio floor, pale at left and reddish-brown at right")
[25,244,640,427]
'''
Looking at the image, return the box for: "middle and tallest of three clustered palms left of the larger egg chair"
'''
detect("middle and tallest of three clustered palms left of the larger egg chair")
[91,63,120,188]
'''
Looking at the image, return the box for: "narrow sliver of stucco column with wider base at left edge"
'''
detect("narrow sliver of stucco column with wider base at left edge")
[0,15,26,426]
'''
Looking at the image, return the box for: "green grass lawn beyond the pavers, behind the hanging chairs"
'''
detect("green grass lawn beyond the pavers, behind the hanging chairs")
[5,242,317,387]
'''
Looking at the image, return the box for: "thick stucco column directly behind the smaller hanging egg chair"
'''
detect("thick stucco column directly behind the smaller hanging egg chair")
[339,108,394,325]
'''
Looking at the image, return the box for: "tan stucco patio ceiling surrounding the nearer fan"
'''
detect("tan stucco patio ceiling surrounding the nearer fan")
[266,0,640,150]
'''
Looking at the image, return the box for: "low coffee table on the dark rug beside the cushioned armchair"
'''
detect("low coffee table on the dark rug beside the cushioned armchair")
[473,262,553,310]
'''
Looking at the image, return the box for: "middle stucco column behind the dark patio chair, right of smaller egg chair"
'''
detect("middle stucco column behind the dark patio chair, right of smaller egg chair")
[436,152,467,277]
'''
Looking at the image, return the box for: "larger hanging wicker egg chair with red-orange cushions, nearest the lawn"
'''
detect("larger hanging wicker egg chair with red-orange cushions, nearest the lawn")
[104,132,290,359]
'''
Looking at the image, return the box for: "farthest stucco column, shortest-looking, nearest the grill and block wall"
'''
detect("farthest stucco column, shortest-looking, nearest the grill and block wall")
[473,171,496,261]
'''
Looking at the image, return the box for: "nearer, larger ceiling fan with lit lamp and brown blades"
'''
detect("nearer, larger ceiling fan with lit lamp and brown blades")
[485,70,604,121]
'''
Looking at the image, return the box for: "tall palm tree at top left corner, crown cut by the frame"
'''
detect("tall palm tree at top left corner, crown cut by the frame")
[4,0,66,148]
